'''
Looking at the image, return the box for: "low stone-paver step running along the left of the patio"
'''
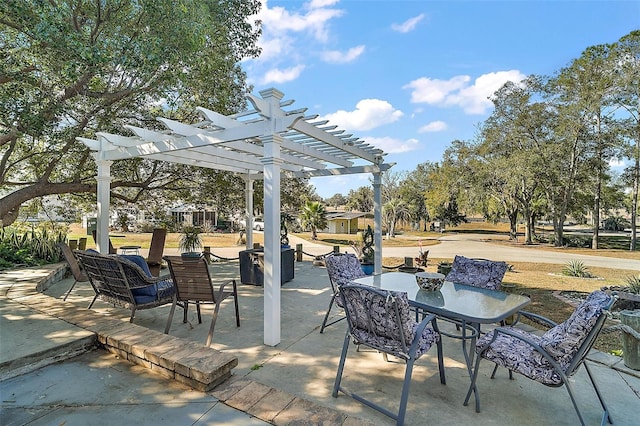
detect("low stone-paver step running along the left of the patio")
[0,268,238,392]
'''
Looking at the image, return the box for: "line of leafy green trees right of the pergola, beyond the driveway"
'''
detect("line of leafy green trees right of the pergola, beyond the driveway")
[327,31,640,250]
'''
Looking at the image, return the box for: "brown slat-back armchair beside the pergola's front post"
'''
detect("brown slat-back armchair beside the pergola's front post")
[163,256,240,346]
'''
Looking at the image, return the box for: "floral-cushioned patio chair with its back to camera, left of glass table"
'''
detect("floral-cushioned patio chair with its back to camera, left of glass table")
[332,284,446,425]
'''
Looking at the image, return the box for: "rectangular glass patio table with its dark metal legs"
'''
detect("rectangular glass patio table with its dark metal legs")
[353,272,531,412]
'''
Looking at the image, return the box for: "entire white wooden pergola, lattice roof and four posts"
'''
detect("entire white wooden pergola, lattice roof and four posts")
[78,88,393,346]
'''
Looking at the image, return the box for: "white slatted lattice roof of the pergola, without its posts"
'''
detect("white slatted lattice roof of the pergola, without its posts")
[78,89,392,178]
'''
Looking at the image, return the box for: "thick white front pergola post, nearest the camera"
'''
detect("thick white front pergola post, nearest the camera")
[262,134,282,346]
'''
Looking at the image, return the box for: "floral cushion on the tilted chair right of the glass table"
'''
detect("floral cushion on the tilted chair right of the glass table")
[476,291,612,386]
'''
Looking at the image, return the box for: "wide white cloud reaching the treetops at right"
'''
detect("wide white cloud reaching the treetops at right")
[403,70,526,114]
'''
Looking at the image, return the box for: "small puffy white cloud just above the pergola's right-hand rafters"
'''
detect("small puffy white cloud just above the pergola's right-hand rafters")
[322,99,403,131]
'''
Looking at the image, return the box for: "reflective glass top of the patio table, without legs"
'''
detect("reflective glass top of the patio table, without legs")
[354,272,531,323]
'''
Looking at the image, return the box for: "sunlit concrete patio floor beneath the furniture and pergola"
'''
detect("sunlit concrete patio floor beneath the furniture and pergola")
[0,248,640,425]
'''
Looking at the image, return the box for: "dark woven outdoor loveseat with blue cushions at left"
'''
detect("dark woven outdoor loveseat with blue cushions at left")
[74,250,175,322]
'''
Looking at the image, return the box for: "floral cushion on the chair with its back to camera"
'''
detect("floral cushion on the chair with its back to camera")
[341,286,440,359]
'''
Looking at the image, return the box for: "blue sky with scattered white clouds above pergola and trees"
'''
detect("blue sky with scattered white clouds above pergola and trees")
[243,0,640,198]
